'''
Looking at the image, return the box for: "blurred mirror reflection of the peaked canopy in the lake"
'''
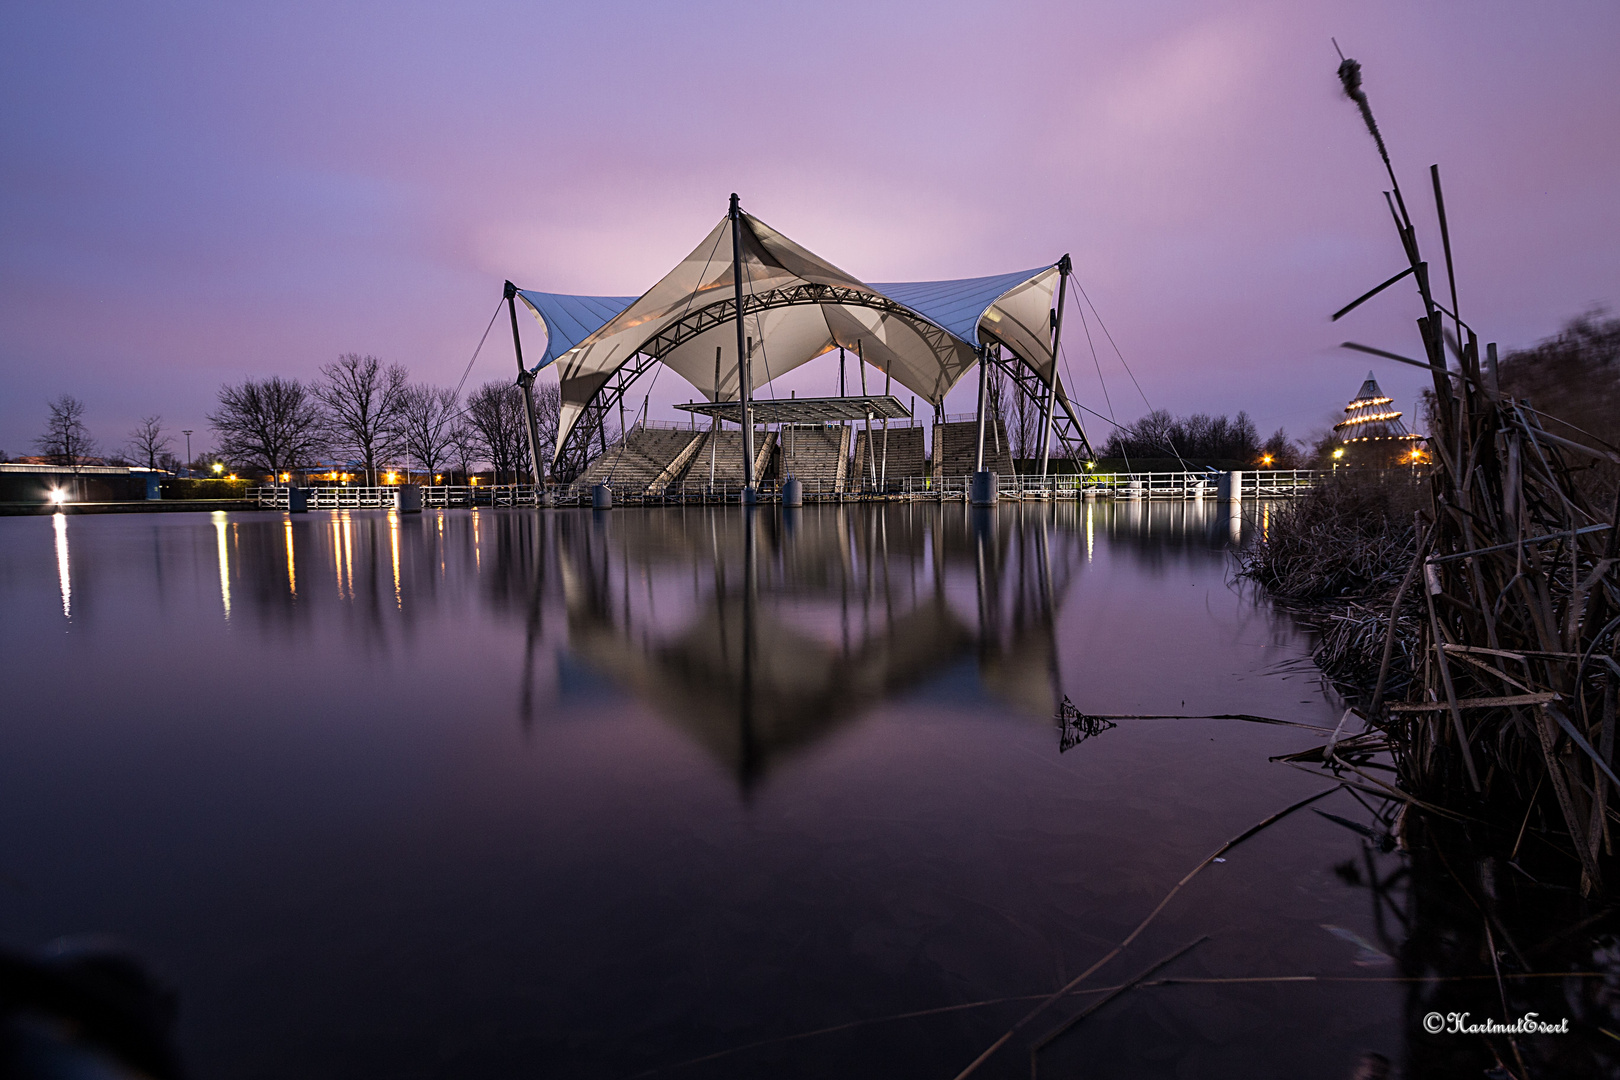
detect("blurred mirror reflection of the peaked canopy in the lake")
[561,507,1079,782]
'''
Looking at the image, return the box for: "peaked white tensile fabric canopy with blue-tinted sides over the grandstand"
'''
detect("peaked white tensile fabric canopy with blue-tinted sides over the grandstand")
[517,214,1063,450]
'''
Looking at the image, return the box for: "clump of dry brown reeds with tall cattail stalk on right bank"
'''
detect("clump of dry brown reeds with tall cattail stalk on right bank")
[1340,60,1620,894]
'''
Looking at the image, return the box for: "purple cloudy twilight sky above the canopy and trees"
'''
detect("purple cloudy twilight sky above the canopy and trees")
[0,0,1620,453]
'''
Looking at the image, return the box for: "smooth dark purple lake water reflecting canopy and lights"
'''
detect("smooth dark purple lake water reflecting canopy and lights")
[0,502,1424,1080]
